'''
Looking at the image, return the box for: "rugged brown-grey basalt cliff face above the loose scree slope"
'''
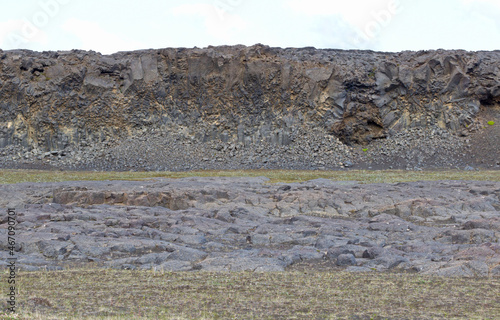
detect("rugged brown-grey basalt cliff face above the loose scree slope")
[0,45,500,169]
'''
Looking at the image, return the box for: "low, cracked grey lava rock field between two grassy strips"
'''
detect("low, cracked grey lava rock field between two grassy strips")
[0,177,500,276]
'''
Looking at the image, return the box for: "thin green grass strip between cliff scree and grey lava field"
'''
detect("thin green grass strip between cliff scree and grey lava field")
[0,169,500,184]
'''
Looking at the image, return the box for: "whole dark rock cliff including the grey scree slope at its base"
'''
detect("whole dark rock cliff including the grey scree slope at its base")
[0,45,500,170]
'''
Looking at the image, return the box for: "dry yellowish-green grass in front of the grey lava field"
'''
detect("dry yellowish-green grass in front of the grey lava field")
[0,270,500,320]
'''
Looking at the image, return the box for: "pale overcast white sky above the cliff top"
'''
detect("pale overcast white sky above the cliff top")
[0,0,500,54]
